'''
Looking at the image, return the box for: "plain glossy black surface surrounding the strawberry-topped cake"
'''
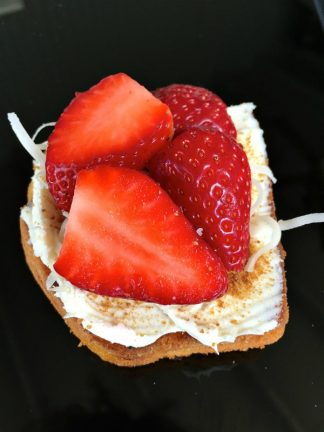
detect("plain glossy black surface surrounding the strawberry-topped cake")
[0,0,324,432]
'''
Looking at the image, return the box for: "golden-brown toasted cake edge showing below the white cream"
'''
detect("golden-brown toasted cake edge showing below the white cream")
[20,177,288,367]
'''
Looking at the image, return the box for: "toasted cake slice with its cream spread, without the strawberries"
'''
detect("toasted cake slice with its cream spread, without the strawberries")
[20,104,288,366]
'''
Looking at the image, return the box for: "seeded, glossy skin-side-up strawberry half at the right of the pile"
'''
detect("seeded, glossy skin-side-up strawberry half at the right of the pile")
[148,129,251,271]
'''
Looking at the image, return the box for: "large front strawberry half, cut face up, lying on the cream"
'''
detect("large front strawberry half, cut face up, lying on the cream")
[54,165,227,304]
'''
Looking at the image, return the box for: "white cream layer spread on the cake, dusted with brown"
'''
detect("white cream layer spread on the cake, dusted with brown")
[21,103,283,352]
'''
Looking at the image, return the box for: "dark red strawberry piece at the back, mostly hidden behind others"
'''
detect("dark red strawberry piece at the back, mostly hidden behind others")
[154,84,236,138]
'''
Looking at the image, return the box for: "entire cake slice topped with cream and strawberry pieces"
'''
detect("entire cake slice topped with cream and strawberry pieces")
[8,74,288,366]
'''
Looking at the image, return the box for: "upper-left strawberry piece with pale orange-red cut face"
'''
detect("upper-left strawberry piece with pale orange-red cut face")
[46,73,173,211]
